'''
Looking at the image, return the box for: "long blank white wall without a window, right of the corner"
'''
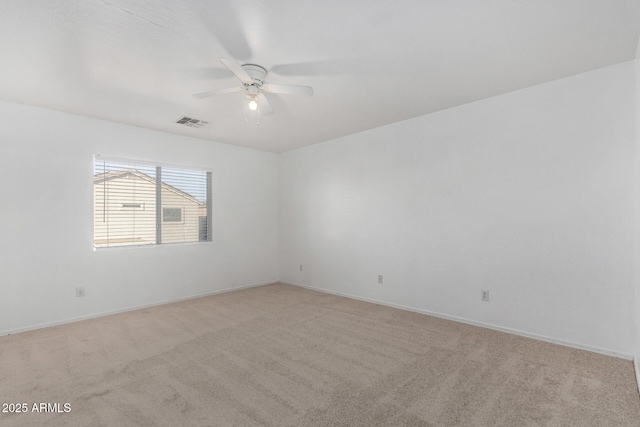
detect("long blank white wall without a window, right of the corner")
[280,62,635,357]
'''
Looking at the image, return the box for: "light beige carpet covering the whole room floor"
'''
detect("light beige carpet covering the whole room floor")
[0,284,640,427]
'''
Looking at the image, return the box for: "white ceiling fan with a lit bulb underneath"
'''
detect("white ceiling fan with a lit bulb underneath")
[193,58,313,114]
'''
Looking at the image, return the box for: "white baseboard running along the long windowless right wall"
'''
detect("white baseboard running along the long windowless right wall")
[280,280,640,362]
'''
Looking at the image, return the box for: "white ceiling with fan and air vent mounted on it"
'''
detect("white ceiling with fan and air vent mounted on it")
[0,0,640,152]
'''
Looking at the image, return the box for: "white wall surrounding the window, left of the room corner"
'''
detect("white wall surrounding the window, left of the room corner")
[0,102,278,334]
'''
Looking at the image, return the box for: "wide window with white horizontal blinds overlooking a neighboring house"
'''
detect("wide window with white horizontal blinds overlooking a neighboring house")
[93,156,211,248]
